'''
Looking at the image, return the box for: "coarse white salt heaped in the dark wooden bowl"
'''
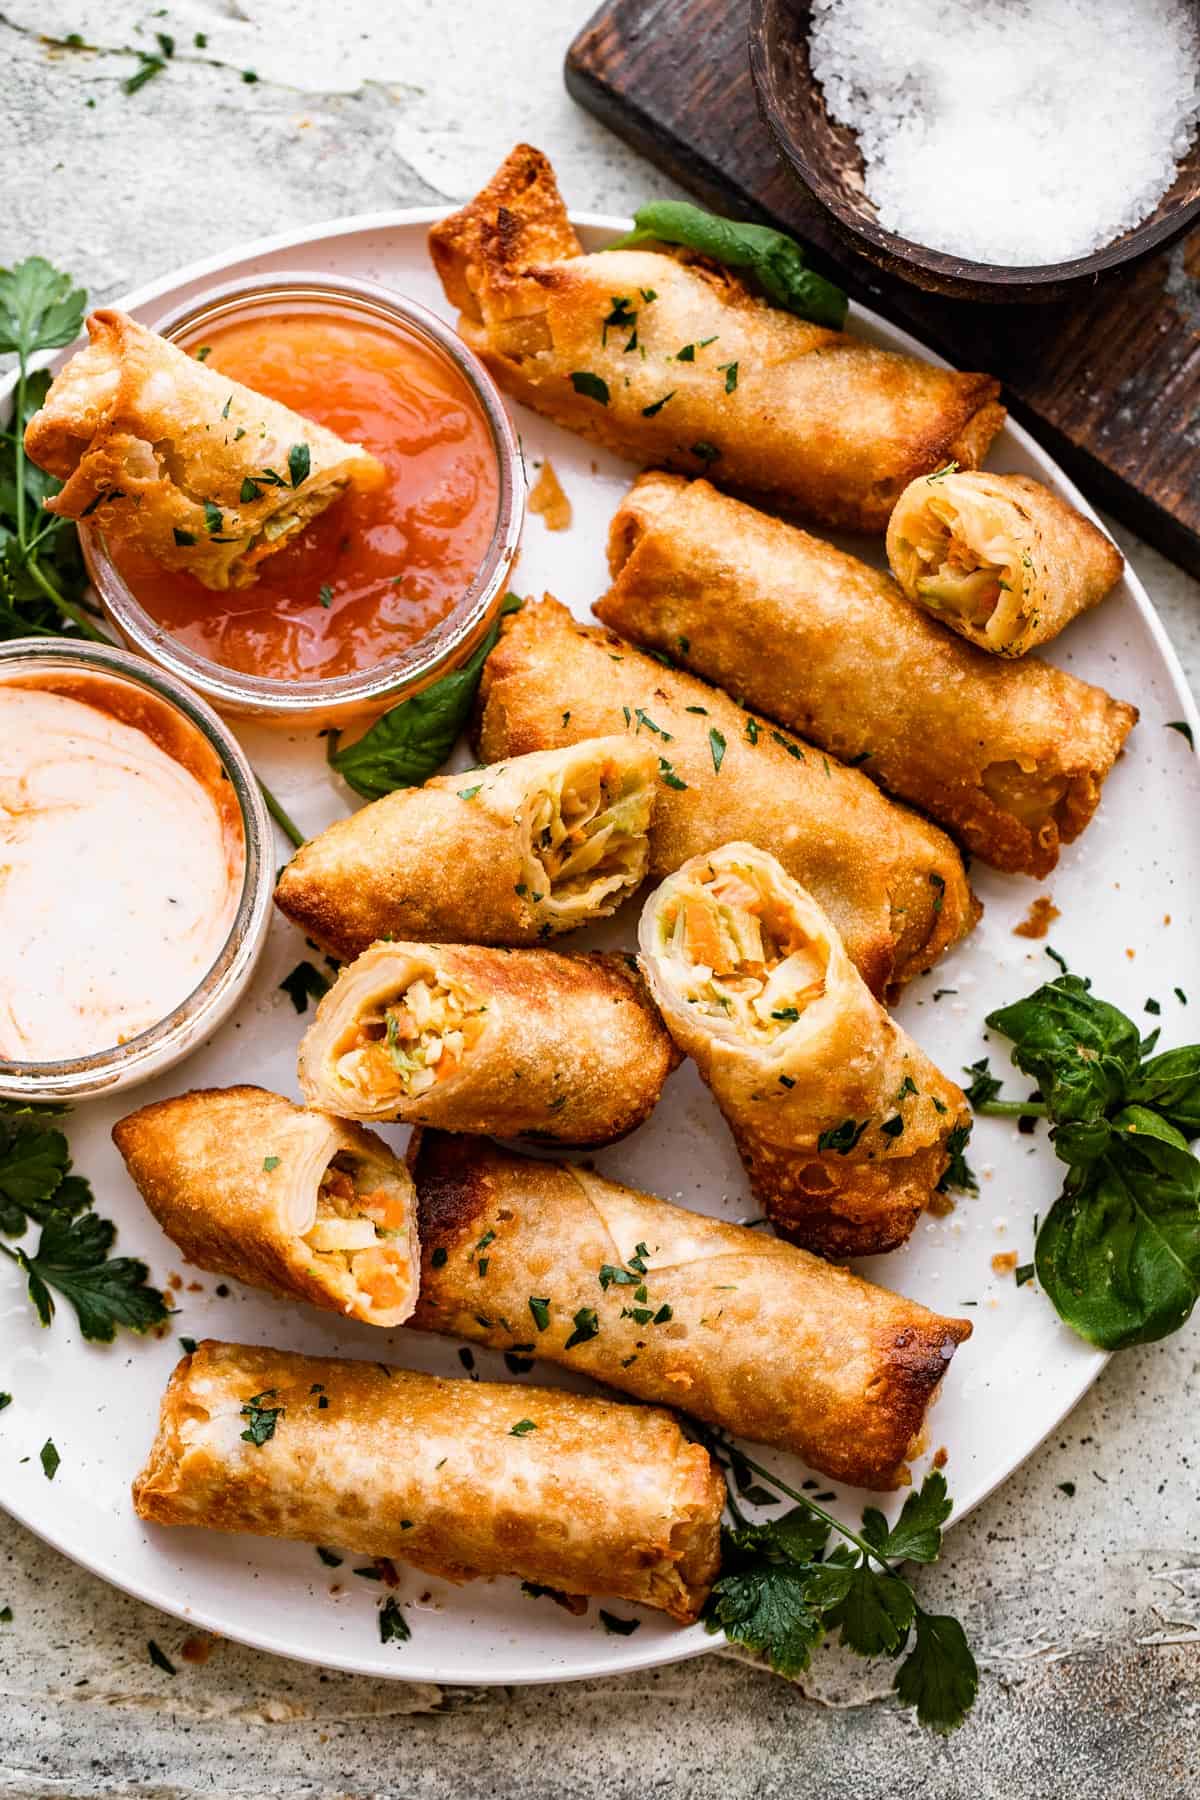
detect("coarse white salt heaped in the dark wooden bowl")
[810,0,1200,268]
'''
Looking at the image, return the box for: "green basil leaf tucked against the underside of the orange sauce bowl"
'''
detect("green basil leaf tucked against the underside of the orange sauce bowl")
[329,594,522,799]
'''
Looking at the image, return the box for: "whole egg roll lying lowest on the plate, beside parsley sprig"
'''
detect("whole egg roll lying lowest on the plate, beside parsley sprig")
[133,1339,725,1624]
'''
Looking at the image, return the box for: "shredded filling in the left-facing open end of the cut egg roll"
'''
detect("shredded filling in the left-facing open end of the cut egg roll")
[335,970,488,1103]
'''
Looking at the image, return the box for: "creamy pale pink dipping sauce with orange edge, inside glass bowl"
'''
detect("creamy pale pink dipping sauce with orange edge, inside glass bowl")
[0,675,245,1062]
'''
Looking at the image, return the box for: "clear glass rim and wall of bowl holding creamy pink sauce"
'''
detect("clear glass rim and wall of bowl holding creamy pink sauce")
[0,637,273,1103]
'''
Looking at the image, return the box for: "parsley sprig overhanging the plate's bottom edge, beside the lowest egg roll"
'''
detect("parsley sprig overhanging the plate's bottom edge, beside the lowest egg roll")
[702,1431,979,1733]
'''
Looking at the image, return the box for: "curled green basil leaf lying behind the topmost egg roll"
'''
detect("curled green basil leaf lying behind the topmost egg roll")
[608,200,847,331]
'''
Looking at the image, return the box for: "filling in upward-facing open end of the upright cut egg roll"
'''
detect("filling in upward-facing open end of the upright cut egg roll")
[658,864,829,1044]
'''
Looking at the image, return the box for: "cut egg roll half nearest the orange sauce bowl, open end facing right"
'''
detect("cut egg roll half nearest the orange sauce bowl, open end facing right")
[275,736,658,961]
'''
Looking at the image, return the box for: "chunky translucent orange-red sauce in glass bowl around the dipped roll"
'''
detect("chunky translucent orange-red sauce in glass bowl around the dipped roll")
[113,313,500,680]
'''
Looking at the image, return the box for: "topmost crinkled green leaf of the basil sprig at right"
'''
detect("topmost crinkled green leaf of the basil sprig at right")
[988,976,1141,1123]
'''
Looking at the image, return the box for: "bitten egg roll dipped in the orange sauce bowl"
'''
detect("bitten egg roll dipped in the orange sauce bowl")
[25,308,383,589]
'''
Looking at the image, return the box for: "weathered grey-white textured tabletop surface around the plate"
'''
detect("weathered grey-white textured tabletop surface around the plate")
[0,0,1200,1800]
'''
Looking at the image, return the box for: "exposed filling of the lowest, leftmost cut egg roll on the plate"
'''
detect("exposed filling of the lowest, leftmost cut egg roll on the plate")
[304,1150,412,1309]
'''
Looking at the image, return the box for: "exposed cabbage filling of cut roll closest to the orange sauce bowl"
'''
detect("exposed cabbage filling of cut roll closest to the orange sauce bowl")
[529,761,649,911]
